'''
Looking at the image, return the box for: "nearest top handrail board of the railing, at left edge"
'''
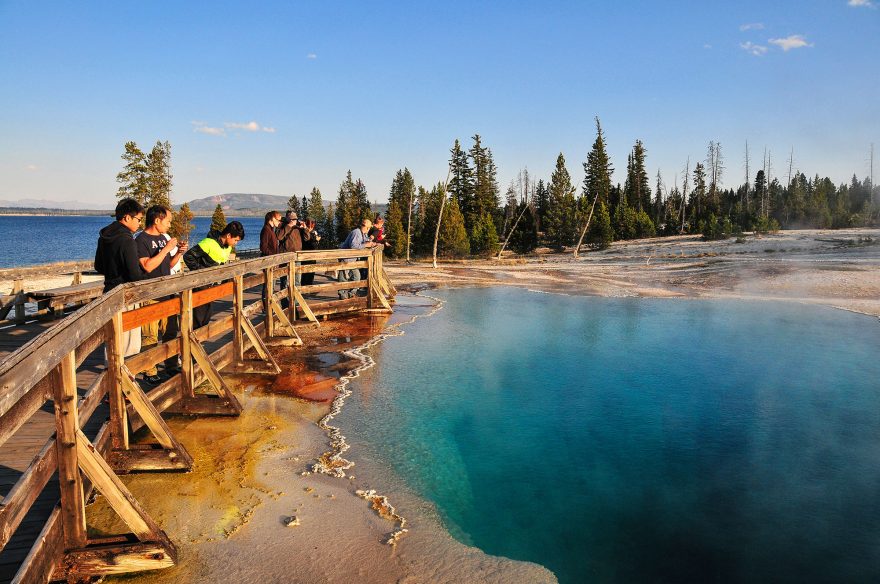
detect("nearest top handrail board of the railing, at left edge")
[0,289,123,415]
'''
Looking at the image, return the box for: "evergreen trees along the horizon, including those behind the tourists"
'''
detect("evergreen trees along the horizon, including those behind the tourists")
[117,131,880,259]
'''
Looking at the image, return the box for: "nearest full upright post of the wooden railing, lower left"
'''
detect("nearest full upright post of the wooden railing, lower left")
[51,351,87,550]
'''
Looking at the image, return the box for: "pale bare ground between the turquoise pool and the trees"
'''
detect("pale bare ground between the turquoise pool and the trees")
[386,229,880,316]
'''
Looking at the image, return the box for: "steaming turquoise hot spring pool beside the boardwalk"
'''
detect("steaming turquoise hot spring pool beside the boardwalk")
[334,288,880,583]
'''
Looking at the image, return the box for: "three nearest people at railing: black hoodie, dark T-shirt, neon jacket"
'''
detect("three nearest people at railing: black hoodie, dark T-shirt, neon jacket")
[95,199,244,384]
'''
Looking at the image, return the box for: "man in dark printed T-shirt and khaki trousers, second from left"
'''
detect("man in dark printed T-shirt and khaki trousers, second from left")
[135,205,187,384]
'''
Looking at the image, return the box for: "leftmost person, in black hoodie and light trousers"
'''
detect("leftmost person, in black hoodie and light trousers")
[95,199,144,357]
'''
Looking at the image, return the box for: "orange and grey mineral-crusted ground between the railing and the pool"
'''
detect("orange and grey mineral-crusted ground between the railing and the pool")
[93,294,556,584]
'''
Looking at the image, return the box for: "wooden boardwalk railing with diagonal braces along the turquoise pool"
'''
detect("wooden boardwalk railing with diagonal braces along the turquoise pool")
[0,248,395,582]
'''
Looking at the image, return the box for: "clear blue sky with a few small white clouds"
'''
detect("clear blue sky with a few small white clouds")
[0,0,880,205]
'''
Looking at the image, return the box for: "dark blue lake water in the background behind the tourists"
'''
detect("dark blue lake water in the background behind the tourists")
[0,215,263,268]
